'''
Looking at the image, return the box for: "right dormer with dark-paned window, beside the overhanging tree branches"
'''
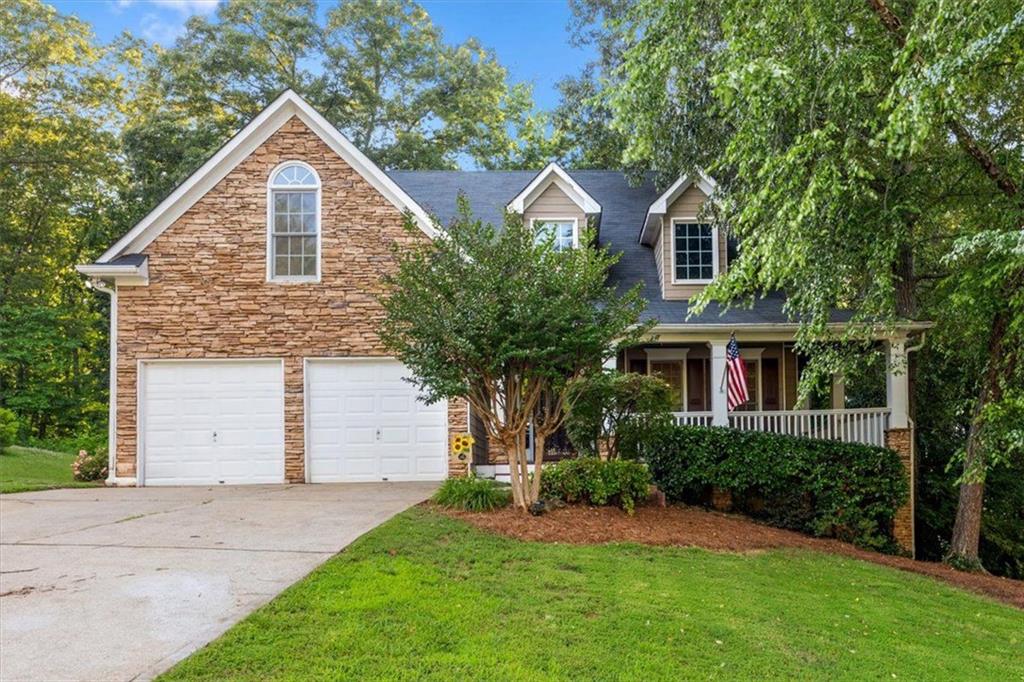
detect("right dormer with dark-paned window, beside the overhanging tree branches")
[640,174,728,300]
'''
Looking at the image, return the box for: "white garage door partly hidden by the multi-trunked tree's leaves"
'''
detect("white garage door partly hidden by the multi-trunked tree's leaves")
[306,359,447,483]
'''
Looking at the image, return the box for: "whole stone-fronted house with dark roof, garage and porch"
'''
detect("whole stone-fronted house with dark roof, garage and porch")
[78,91,924,548]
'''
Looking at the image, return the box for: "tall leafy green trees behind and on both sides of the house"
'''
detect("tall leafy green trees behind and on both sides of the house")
[0,0,1024,578]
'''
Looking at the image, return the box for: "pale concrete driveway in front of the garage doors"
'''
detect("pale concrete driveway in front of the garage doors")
[0,483,435,682]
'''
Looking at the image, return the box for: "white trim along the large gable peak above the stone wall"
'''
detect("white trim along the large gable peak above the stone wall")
[96,90,436,263]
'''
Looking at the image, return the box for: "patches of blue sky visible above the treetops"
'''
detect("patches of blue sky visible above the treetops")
[51,0,592,109]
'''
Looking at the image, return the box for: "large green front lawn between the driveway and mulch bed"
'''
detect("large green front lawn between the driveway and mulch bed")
[161,509,1024,680]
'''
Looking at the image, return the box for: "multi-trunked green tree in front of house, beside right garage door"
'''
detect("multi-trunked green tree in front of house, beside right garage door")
[381,197,648,509]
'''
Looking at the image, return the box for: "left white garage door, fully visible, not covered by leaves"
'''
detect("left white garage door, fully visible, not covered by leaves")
[140,360,285,485]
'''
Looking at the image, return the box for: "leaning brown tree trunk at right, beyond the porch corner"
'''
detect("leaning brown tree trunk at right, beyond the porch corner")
[946,306,1010,570]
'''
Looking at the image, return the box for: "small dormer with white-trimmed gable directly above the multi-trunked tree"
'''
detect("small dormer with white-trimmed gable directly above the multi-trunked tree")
[506,163,601,249]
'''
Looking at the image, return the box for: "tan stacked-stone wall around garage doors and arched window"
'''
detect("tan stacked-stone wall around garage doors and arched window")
[117,117,460,482]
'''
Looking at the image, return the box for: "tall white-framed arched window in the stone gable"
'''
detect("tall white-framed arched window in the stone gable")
[267,161,321,282]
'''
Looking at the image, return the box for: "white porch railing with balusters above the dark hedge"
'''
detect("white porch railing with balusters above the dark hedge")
[673,408,889,445]
